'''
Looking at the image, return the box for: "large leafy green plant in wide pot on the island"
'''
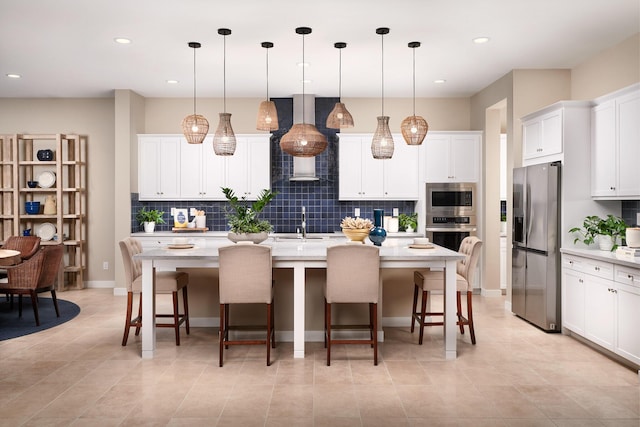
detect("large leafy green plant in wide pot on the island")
[222,187,278,243]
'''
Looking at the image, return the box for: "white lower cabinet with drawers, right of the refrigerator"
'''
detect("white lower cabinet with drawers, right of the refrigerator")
[562,254,640,365]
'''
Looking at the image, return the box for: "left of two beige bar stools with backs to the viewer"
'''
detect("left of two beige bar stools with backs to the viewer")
[219,242,276,367]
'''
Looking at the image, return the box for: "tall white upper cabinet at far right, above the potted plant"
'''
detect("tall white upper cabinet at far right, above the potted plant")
[591,85,640,199]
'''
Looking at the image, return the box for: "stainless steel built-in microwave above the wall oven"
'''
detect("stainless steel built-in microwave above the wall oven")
[426,182,477,216]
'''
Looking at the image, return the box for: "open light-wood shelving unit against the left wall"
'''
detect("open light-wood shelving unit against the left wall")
[0,134,86,290]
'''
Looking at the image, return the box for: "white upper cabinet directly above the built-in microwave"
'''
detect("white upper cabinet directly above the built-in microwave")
[423,132,481,182]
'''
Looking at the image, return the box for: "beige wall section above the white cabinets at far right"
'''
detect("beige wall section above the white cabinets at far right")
[571,33,640,100]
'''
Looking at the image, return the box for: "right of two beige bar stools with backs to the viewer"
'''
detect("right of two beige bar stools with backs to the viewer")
[324,244,381,366]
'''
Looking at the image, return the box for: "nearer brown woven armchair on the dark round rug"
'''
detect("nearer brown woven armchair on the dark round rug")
[0,245,63,326]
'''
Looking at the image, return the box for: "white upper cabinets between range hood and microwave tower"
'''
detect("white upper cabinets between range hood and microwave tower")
[338,134,420,200]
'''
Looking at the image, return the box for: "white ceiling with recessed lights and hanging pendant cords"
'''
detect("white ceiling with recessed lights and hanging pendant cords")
[0,0,640,98]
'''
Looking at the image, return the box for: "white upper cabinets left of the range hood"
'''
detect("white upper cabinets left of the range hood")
[138,134,271,200]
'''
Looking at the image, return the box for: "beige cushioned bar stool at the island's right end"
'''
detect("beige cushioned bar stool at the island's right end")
[411,236,482,345]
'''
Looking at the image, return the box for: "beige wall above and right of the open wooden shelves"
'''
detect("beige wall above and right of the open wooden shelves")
[0,98,115,282]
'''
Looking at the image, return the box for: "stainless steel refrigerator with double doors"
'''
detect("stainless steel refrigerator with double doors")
[511,162,561,332]
